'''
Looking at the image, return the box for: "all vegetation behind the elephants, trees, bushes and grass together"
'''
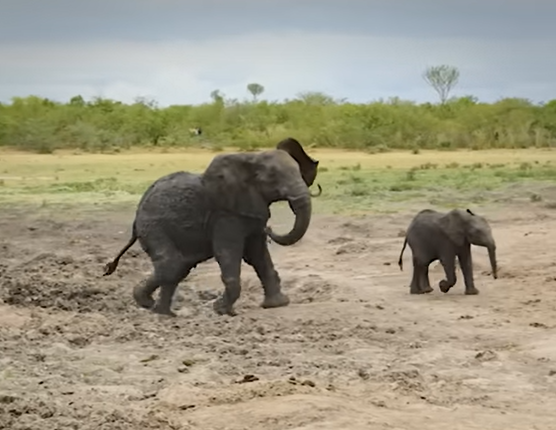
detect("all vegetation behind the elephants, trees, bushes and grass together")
[0,65,556,212]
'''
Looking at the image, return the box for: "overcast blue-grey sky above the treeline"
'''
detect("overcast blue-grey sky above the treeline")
[0,0,556,106]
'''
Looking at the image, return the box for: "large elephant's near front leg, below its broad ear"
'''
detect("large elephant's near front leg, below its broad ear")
[213,223,245,316]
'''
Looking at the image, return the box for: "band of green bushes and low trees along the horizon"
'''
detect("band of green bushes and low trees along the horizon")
[0,92,556,153]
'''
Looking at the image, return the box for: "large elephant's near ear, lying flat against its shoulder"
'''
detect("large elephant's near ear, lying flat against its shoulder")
[202,154,270,222]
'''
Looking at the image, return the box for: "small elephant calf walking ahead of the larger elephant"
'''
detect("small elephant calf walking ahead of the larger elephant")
[398,209,498,294]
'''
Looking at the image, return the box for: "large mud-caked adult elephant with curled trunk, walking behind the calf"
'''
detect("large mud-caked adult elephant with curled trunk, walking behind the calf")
[104,150,311,316]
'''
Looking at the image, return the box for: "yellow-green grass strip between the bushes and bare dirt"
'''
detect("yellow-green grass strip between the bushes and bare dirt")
[0,149,556,212]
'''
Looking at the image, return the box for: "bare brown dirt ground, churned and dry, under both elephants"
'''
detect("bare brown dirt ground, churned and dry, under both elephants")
[0,203,556,430]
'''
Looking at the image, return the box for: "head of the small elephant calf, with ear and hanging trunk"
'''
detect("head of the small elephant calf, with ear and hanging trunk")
[440,209,498,279]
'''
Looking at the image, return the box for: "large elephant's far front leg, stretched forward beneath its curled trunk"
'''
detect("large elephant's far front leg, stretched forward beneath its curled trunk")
[247,233,290,309]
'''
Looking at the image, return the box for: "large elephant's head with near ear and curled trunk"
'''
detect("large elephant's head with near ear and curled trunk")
[202,150,312,246]
